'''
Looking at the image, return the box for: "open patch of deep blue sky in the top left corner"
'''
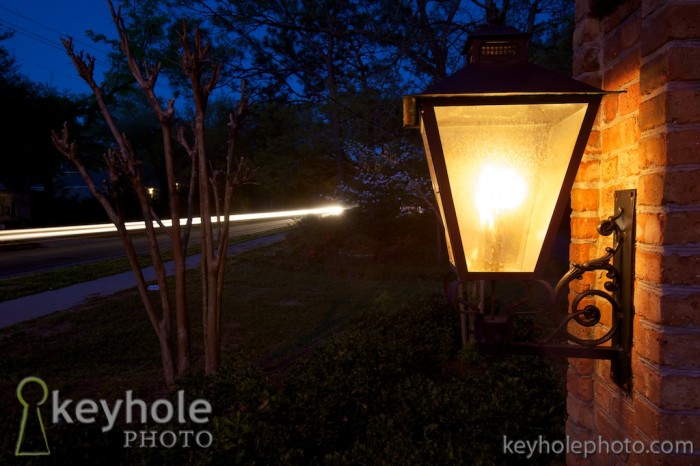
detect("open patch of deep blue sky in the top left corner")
[0,0,116,93]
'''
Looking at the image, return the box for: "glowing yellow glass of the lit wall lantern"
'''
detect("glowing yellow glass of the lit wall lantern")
[431,103,588,272]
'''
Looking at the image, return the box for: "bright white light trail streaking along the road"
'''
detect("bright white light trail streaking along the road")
[0,205,346,242]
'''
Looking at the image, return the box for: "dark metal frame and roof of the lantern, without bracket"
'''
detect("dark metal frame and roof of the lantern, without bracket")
[404,26,608,280]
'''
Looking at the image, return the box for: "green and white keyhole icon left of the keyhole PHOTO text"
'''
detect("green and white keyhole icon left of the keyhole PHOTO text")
[15,377,51,456]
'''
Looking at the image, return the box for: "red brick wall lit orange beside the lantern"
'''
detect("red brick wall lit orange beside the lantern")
[567,0,700,465]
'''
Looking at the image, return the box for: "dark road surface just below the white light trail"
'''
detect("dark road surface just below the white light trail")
[0,218,293,278]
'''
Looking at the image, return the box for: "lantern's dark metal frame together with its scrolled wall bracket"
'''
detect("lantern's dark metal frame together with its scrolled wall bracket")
[404,26,636,389]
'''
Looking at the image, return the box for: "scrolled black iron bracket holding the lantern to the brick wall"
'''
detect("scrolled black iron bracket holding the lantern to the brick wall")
[448,190,636,390]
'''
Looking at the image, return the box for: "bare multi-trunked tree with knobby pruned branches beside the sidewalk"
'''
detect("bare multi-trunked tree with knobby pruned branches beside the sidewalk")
[52,0,249,387]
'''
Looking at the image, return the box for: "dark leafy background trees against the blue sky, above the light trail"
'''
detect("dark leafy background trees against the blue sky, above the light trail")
[0,0,574,224]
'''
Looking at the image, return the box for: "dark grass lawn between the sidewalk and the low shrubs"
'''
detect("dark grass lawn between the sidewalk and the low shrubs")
[0,215,444,412]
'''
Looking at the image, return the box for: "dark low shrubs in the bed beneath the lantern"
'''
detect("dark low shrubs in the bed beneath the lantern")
[270,296,565,464]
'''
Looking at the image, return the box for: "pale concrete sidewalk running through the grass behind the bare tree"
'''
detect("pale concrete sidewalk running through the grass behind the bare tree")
[0,233,285,328]
